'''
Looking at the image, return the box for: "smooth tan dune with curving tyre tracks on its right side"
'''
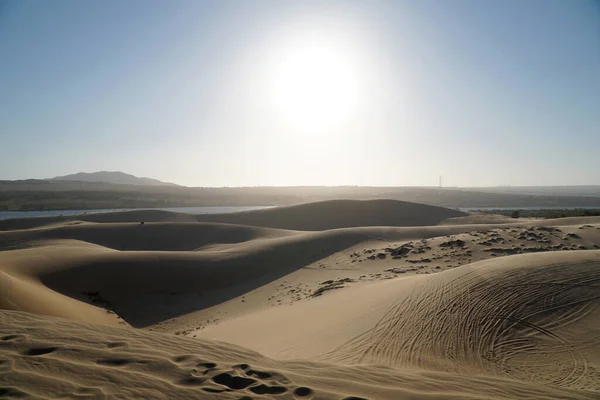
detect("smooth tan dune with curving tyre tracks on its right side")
[198,251,600,390]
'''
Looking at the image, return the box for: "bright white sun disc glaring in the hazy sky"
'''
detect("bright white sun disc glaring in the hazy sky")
[268,37,360,134]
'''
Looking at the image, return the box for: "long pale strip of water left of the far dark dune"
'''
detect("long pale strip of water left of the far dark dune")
[0,206,271,220]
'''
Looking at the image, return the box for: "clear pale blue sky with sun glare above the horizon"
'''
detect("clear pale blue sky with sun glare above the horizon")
[0,0,600,187]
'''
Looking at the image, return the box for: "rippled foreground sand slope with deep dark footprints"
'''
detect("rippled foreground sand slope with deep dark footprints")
[0,311,597,400]
